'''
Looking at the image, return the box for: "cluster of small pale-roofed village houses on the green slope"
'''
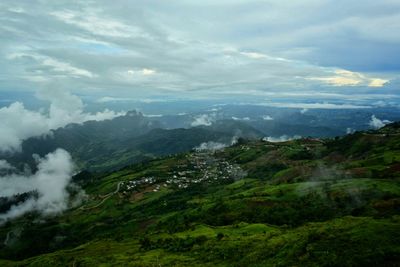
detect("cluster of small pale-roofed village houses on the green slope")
[119,150,245,195]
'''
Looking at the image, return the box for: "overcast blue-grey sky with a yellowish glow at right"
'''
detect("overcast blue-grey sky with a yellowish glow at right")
[0,0,400,104]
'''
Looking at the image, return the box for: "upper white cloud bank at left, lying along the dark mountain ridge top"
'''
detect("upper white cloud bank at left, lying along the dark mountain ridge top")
[0,90,124,152]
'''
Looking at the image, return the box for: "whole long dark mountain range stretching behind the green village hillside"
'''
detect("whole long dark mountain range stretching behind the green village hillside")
[0,111,263,171]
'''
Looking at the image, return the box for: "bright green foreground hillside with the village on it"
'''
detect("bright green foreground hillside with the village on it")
[0,124,400,266]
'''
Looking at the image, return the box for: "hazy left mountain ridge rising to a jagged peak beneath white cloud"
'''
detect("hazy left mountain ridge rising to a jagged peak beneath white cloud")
[1,111,160,172]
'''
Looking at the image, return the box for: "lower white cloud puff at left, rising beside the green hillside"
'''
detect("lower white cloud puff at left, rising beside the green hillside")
[0,149,74,222]
